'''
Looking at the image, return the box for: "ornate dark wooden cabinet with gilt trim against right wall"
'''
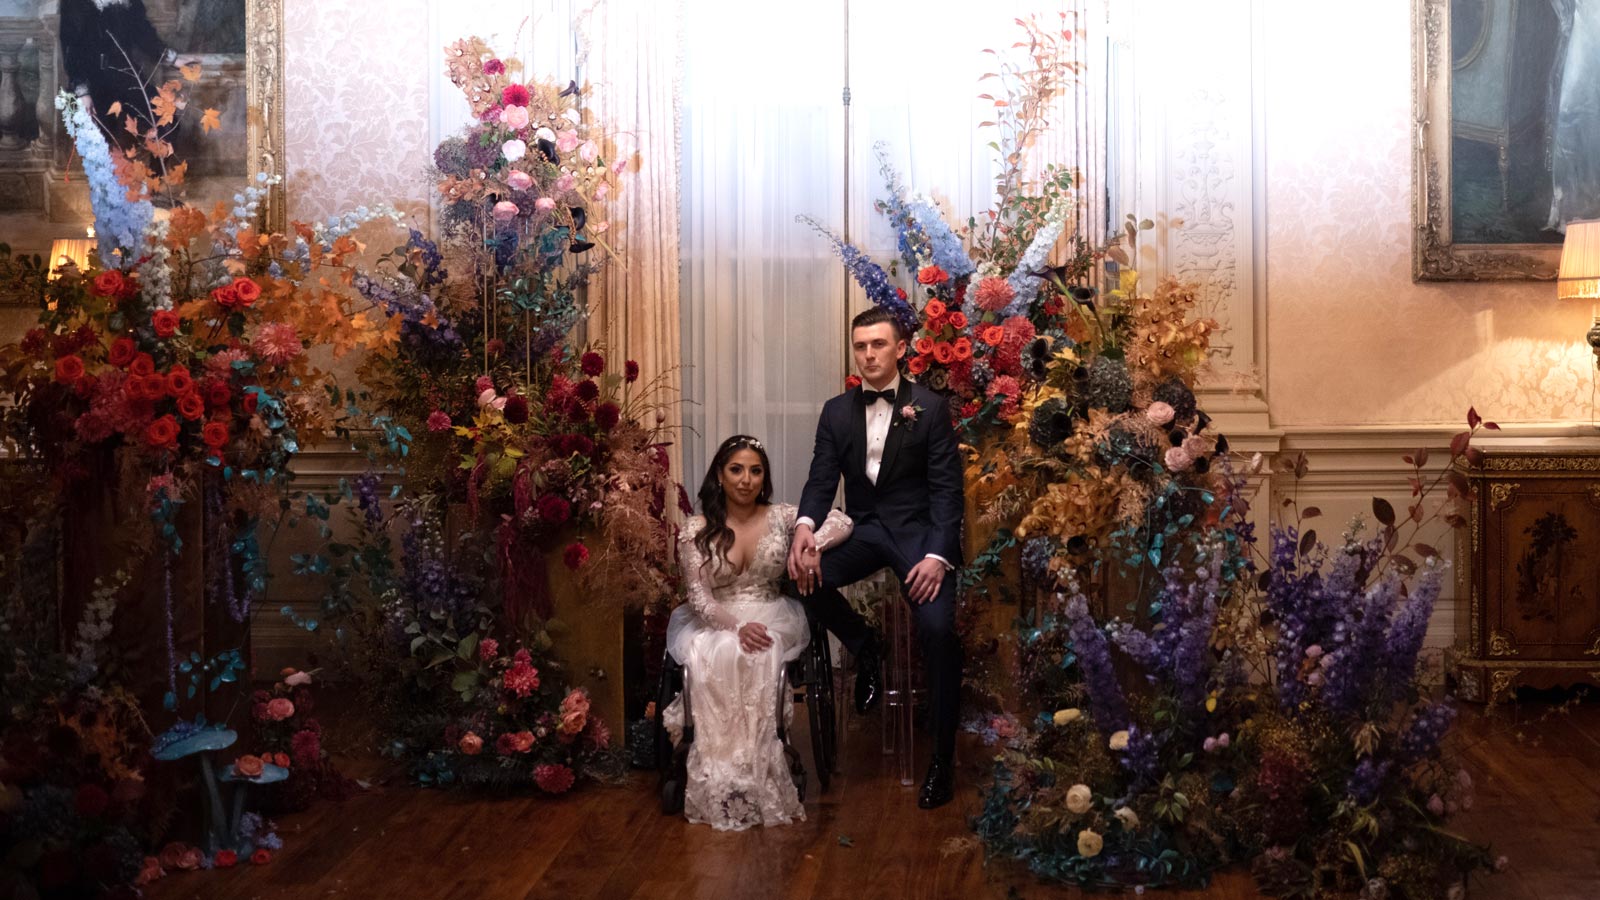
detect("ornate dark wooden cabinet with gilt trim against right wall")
[1456,452,1600,701]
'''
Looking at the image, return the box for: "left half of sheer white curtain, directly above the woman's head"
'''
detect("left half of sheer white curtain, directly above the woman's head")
[682,0,845,503]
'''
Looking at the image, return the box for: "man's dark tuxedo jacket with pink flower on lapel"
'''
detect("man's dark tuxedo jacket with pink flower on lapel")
[800,378,965,565]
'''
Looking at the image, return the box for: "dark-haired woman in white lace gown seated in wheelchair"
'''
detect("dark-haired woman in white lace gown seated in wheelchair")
[662,434,851,831]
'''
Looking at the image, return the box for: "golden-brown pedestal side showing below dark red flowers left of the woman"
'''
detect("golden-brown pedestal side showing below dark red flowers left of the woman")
[544,541,626,743]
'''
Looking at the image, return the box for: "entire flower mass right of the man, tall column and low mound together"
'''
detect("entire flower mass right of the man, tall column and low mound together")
[805,14,1491,900]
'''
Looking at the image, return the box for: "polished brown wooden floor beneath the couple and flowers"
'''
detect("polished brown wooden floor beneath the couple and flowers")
[150,701,1600,900]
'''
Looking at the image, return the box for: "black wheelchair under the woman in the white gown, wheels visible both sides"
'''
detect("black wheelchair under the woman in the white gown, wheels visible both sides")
[654,598,838,815]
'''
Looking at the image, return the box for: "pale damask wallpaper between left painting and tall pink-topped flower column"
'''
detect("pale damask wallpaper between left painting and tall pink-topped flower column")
[283,0,442,223]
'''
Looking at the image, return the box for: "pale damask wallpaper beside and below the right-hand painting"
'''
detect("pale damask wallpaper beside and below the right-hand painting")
[1256,0,1595,426]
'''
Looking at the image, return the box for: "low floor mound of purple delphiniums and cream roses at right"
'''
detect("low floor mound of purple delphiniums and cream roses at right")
[978,413,1504,900]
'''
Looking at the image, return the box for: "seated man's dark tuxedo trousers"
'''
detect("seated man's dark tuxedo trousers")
[803,520,962,761]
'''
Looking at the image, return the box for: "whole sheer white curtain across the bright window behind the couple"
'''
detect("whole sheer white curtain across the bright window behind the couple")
[682,0,1107,500]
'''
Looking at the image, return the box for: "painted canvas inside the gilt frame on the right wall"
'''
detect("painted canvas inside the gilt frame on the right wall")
[1450,0,1600,245]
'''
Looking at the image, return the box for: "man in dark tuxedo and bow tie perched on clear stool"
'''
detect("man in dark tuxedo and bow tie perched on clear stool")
[789,307,965,809]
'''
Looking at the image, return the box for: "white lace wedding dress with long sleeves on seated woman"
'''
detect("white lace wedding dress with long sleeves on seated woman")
[662,503,851,831]
